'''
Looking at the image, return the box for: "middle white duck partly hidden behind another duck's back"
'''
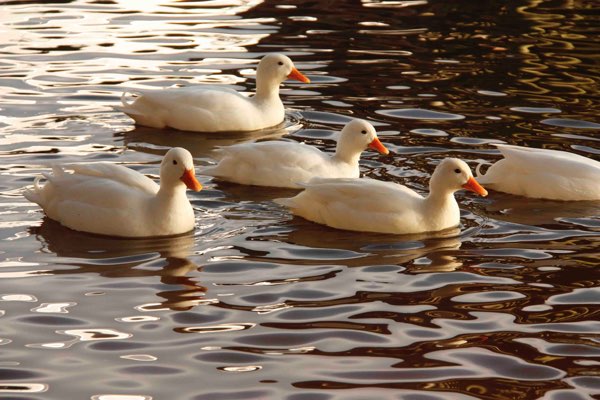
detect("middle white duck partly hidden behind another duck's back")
[203,119,389,188]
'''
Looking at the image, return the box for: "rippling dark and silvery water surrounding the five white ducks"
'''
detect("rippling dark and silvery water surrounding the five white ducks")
[0,0,600,400]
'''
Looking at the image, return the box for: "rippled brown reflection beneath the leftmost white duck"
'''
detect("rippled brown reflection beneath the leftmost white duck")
[30,218,207,310]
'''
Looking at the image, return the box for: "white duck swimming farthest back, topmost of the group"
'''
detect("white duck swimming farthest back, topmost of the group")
[119,54,310,132]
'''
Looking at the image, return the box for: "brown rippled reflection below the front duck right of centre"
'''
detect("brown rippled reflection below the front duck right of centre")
[276,218,469,273]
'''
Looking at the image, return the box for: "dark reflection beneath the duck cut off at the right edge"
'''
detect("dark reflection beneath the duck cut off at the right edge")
[483,192,600,226]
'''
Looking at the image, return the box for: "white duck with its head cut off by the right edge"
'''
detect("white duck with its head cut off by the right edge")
[477,144,600,201]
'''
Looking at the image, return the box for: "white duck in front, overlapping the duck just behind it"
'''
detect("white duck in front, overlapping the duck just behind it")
[275,158,487,234]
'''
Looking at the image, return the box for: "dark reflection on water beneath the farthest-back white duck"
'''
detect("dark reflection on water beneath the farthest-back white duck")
[116,121,292,157]
